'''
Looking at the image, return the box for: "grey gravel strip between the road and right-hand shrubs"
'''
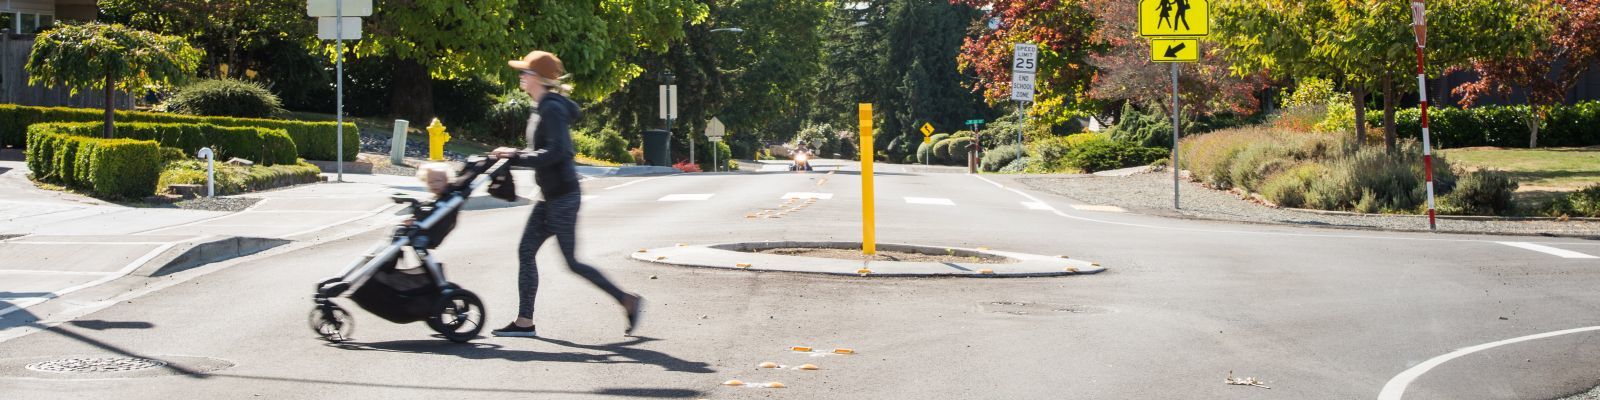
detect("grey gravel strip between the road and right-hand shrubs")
[1018,173,1600,237]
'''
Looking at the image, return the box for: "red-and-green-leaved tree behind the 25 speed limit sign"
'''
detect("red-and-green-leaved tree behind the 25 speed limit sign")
[950,0,1118,125]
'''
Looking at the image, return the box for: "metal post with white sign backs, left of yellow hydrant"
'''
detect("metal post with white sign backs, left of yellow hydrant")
[306,0,373,182]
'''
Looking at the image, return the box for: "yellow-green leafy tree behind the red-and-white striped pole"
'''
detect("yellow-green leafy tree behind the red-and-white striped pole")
[1213,0,1549,149]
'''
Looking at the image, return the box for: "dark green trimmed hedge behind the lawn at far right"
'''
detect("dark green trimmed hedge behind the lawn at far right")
[1366,101,1600,149]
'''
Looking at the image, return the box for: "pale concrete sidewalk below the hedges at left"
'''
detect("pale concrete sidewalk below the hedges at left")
[0,158,438,318]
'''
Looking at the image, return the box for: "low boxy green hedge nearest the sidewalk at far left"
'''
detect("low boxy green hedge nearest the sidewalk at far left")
[27,125,162,198]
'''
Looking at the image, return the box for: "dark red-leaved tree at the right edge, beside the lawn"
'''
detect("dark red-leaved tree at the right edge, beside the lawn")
[1454,0,1600,147]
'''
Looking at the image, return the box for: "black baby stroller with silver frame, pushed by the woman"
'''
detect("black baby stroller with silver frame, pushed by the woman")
[310,158,515,342]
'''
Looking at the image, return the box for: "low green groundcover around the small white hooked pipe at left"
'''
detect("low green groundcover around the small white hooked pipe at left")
[154,160,322,195]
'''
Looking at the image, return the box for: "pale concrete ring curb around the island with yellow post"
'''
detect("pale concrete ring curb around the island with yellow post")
[629,242,1106,278]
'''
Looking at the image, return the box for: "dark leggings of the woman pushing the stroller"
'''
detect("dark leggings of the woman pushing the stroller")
[517,192,627,318]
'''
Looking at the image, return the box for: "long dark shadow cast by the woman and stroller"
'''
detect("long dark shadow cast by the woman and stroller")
[326,338,714,373]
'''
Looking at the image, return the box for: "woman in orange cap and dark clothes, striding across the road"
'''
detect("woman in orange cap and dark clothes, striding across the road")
[491,51,643,338]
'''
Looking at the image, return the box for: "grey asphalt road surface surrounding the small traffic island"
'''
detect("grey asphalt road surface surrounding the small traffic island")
[0,168,1600,398]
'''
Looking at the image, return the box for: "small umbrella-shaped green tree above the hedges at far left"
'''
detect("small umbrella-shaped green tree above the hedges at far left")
[27,22,202,138]
